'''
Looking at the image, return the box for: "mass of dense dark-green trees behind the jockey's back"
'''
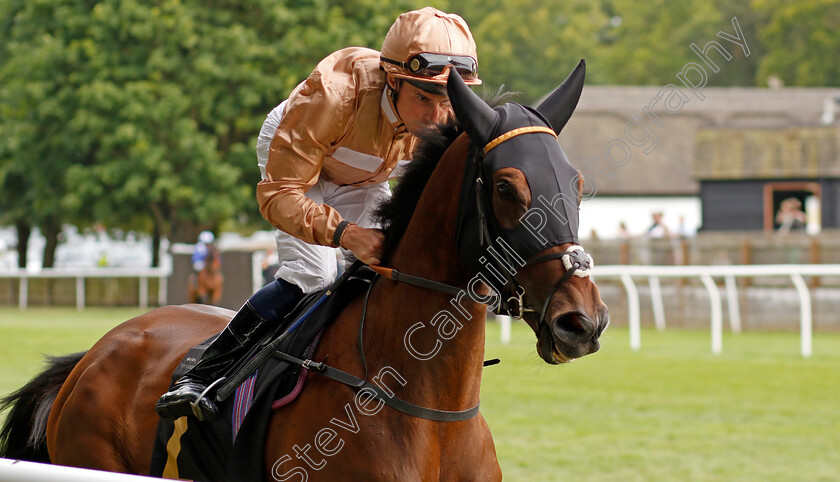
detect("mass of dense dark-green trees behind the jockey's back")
[0,0,414,263]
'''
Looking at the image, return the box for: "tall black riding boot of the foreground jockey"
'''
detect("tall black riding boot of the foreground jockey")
[155,280,303,421]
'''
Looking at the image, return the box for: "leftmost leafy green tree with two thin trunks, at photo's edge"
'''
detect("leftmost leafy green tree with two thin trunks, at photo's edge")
[0,0,90,267]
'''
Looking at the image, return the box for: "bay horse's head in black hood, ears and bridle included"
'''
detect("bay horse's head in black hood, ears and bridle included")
[447,61,609,364]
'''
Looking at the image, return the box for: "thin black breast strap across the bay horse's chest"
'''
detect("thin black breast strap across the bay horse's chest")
[273,351,480,422]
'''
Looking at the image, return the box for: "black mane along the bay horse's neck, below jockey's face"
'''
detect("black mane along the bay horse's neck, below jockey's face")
[373,122,461,264]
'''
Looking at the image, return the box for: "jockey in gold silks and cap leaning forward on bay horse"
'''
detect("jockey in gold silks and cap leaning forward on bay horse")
[156,7,481,420]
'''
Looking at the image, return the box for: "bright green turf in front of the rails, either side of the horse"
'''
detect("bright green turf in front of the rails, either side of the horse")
[0,307,840,481]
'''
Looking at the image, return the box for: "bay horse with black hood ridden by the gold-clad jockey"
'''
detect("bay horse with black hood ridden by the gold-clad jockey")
[0,62,609,480]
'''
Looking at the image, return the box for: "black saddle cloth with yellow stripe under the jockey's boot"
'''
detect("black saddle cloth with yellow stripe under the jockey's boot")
[150,270,372,482]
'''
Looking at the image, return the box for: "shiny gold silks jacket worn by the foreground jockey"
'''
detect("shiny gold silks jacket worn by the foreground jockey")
[257,47,416,246]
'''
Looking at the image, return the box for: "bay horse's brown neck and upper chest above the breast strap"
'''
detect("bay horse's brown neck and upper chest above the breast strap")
[368,138,486,410]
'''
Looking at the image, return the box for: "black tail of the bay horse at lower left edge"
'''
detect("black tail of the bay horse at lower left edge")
[0,352,85,463]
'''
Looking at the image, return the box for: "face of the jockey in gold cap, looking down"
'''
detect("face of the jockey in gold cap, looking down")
[388,78,454,136]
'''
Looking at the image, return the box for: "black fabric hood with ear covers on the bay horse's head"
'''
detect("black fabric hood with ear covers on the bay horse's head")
[447,60,585,272]
